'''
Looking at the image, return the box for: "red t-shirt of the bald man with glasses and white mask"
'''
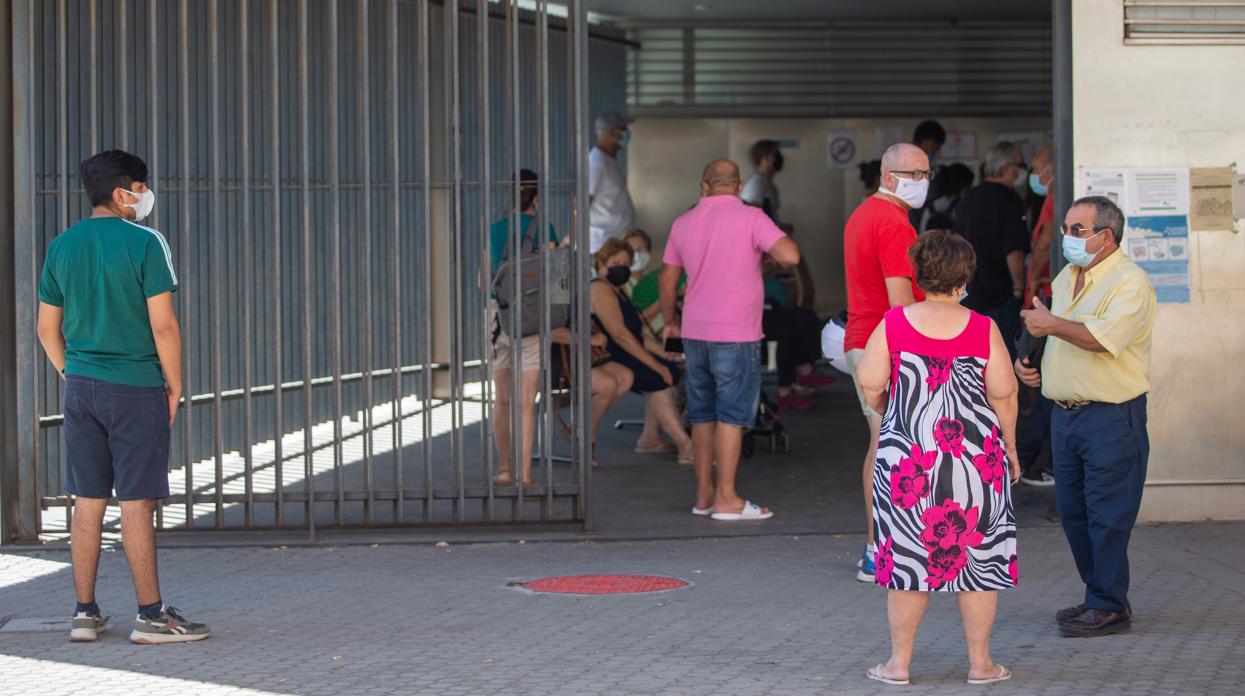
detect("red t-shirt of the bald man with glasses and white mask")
[843,195,925,351]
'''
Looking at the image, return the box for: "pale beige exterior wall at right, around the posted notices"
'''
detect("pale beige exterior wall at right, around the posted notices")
[1072,0,1245,520]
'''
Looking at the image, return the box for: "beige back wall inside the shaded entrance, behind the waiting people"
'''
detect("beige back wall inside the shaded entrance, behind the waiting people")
[626,118,1051,314]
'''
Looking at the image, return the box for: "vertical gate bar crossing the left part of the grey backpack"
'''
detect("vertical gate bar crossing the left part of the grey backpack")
[505,0,522,520]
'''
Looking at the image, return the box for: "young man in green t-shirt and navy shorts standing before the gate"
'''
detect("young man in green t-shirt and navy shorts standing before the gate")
[39,149,212,645]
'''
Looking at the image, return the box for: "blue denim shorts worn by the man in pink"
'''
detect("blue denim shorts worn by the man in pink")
[684,339,761,428]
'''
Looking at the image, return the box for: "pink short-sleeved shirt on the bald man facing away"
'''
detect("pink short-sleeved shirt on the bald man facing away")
[664,195,784,344]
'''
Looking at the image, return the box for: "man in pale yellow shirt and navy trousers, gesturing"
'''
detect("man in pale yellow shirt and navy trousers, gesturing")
[1016,195,1154,637]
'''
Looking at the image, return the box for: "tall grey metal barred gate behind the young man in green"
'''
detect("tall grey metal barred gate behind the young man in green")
[12,0,625,539]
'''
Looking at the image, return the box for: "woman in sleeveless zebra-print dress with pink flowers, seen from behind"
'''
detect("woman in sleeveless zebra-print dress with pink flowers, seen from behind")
[858,232,1020,685]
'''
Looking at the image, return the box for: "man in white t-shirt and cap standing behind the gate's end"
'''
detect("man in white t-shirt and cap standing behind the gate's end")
[588,111,635,253]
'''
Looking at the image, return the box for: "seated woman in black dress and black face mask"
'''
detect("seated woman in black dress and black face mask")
[591,239,692,464]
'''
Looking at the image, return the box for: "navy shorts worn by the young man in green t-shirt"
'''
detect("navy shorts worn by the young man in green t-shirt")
[65,375,169,501]
